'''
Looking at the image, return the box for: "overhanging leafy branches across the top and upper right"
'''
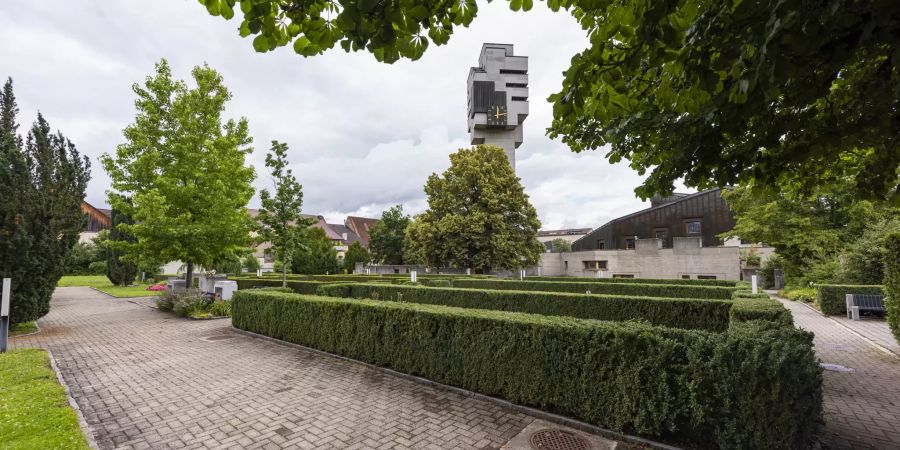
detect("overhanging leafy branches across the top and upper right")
[200,0,900,201]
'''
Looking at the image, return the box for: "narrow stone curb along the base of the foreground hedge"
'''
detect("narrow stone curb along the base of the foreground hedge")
[231,326,682,450]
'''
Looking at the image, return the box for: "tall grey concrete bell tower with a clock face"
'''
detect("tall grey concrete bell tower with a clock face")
[468,44,528,170]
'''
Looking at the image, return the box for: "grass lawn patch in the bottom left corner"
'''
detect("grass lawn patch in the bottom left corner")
[0,349,90,449]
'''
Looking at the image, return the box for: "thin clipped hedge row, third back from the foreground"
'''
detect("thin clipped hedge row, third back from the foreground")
[453,279,738,299]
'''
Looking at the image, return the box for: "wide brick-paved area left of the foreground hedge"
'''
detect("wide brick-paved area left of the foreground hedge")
[11,288,535,449]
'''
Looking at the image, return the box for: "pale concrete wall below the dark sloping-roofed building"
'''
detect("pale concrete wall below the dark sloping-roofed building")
[540,238,741,280]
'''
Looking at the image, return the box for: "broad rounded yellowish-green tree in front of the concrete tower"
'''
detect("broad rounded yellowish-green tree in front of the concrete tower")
[407,145,544,272]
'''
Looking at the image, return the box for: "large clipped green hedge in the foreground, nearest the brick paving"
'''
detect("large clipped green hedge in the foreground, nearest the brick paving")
[232,291,822,449]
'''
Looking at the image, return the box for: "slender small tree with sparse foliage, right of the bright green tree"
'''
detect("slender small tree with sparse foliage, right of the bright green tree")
[256,141,314,281]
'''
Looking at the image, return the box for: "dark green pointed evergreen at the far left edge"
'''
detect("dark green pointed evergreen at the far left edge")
[0,79,90,325]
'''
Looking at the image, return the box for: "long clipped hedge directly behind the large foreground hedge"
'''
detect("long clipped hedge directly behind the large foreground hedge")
[316,283,732,331]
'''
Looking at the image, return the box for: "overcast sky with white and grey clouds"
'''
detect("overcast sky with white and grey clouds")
[0,0,684,229]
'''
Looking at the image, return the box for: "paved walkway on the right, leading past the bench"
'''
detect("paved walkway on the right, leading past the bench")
[779,299,900,450]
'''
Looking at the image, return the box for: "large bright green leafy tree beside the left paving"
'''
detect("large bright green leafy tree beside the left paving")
[101,59,254,287]
